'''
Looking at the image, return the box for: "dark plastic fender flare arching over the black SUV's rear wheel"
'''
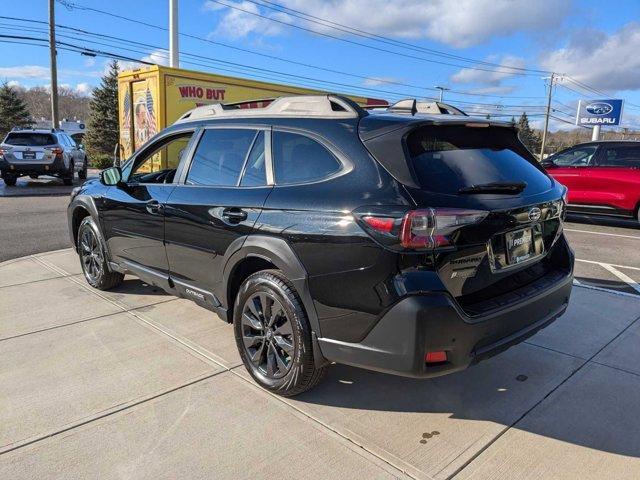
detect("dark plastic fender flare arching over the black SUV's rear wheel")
[222,235,321,337]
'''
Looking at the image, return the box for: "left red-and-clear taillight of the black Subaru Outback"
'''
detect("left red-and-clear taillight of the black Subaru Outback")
[361,208,489,250]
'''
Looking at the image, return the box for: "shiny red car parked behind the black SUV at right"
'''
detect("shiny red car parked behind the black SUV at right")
[543,141,640,222]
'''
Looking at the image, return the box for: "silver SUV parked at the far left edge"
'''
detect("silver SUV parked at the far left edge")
[0,129,87,186]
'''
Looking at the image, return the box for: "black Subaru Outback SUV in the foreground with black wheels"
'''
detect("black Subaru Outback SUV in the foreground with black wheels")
[68,96,573,395]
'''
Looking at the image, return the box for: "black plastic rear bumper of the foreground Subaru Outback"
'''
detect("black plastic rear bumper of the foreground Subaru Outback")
[318,262,573,377]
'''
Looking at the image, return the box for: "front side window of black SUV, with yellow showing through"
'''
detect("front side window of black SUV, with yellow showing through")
[128,132,193,183]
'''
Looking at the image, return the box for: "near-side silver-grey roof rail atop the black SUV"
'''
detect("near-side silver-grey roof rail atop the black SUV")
[175,95,367,124]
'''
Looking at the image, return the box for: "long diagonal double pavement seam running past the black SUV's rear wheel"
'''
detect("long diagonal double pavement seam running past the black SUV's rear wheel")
[32,255,422,479]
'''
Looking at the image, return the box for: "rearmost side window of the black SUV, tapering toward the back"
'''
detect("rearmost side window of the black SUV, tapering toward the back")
[273,131,342,185]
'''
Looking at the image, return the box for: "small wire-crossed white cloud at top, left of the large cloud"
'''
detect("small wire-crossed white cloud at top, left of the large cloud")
[204,1,291,38]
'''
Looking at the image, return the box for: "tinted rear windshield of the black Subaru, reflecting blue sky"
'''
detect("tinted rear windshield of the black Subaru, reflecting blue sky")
[406,125,551,194]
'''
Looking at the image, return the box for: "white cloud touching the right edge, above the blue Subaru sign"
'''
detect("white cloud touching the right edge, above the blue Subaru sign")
[541,22,640,92]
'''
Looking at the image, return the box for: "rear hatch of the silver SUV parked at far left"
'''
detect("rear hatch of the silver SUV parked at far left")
[2,132,60,163]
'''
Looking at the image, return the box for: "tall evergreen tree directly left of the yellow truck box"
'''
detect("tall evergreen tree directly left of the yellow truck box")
[84,60,119,160]
